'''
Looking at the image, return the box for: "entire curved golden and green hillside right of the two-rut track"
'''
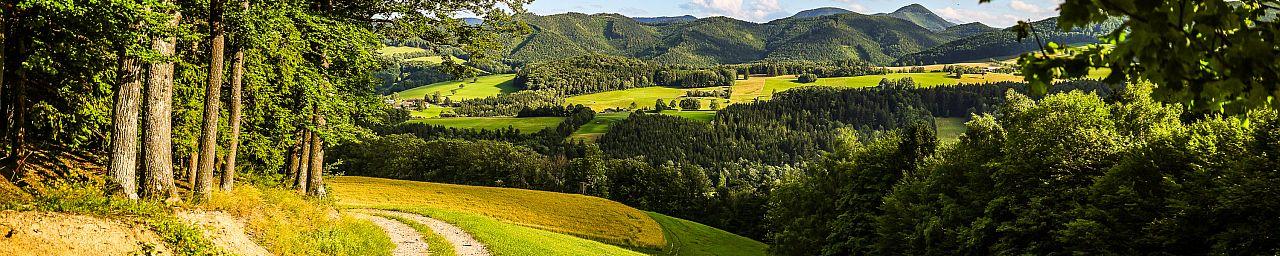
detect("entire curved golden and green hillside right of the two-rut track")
[329,177,763,255]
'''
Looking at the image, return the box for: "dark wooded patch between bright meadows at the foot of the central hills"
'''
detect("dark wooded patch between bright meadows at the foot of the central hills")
[516,55,737,95]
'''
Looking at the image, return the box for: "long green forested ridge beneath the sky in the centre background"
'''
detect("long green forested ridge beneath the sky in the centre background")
[507,6,960,65]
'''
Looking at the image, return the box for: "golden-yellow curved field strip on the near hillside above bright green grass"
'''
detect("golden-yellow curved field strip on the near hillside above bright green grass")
[329,177,666,250]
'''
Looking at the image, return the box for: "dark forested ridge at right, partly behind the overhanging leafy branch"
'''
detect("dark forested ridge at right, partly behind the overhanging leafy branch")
[893,18,1120,65]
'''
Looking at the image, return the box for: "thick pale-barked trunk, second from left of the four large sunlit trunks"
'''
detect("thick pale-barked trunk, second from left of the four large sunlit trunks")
[142,13,182,200]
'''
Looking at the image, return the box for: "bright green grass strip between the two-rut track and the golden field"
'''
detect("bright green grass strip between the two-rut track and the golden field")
[383,207,644,256]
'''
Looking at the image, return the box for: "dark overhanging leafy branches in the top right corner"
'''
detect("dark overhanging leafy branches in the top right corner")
[1003,0,1280,114]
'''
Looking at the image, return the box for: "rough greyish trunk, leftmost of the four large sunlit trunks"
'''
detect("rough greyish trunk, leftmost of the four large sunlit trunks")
[110,46,143,200]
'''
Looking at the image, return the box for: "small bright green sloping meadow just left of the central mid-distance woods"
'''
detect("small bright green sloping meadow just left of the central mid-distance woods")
[396,74,520,101]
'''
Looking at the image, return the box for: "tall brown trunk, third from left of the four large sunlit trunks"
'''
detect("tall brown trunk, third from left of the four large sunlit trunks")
[196,0,227,200]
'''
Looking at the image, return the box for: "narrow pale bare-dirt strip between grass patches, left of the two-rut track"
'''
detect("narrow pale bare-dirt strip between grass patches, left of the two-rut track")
[177,211,271,256]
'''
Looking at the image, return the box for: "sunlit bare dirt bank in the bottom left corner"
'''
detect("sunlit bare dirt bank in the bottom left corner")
[0,211,172,256]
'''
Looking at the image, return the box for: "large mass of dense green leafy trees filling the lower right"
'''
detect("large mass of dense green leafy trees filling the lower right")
[768,90,1280,255]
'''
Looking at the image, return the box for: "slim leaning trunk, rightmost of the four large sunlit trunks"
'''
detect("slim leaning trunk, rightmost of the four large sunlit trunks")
[221,0,248,191]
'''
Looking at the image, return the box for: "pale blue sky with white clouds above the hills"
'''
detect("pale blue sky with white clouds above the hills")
[527,0,1061,27]
